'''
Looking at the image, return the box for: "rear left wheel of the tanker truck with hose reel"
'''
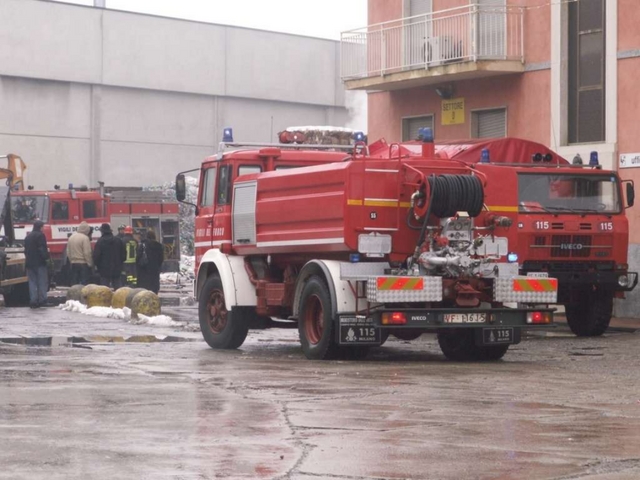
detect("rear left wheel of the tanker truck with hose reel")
[298,276,339,360]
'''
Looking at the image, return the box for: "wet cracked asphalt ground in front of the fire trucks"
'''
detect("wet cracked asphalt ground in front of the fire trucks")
[0,307,640,480]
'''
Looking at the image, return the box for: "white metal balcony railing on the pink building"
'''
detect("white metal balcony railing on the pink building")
[340,4,524,80]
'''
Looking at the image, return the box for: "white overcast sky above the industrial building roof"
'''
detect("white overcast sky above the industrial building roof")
[58,0,367,40]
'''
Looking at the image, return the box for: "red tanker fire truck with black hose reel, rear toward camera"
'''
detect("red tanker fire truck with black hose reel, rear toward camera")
[176,129,557,360]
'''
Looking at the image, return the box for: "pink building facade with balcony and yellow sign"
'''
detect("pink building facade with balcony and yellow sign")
[342,0,640,316]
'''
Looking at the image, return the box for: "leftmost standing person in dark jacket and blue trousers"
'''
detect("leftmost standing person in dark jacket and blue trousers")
[24,220,49,308]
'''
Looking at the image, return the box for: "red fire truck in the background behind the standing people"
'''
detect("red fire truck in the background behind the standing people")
[5,185,180,285]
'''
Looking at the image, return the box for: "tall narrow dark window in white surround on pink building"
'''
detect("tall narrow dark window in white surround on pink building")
[568,0,606,143]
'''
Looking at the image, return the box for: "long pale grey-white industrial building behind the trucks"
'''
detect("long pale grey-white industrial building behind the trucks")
[0,0,356,189]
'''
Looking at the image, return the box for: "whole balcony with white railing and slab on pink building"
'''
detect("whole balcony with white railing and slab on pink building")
[340,4,524,90]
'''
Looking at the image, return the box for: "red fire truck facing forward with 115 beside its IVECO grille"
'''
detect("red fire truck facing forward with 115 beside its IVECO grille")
[370,138,638,336]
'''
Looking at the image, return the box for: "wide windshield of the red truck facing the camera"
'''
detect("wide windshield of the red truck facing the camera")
[518,173,620,214]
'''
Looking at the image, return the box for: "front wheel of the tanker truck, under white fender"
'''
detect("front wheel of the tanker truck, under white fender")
[198,275,249,350]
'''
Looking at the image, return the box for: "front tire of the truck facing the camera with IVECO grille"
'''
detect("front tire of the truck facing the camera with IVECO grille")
[565,291,613,337]
